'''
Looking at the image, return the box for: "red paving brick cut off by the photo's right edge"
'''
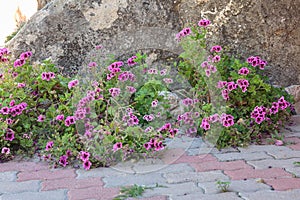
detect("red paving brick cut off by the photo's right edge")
[264,178,300,191]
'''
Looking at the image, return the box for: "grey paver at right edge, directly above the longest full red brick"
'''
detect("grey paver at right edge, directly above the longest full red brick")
[247,158,299,169]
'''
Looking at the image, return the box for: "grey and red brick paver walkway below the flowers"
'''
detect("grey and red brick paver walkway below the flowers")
[0,115,300,200]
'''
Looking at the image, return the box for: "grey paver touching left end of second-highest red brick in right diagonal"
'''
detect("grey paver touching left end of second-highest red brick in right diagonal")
[133,163,195,174]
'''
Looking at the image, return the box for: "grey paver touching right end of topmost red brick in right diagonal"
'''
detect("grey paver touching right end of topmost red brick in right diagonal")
[214,152,272,161]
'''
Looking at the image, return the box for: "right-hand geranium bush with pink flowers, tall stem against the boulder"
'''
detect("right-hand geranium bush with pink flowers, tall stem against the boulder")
[177,20,293,148]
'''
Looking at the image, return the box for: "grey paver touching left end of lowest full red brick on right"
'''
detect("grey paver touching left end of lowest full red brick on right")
[163,171,229,183]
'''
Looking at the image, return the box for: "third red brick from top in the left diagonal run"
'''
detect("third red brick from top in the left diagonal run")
[42,178,103,190]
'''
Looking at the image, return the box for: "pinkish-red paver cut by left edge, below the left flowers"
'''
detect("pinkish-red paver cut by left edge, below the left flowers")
[0,162,49,172]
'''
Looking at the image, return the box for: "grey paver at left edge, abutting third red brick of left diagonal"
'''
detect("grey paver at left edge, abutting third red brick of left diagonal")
[0,180,40,193]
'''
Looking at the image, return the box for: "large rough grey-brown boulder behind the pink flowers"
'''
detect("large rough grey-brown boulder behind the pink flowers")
[9,0,300,86]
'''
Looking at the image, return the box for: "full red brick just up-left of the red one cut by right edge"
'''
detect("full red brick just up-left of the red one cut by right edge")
[224,168,292,180]
